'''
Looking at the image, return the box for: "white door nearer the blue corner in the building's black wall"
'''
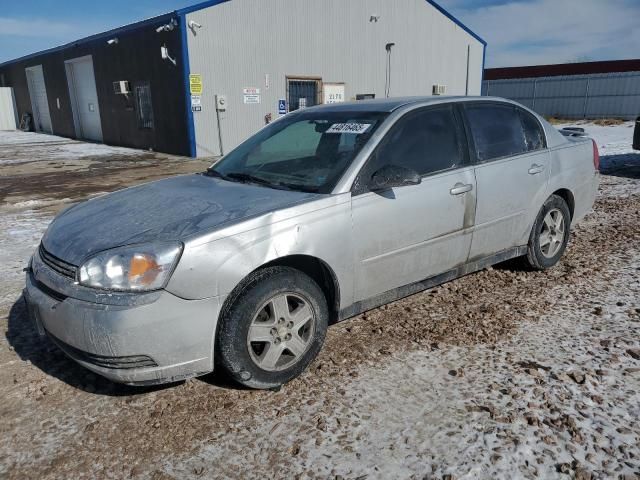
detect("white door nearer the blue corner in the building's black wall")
[65,55,102,142]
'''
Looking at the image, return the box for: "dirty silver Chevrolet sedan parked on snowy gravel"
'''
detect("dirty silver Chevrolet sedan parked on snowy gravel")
[25,97,598,388]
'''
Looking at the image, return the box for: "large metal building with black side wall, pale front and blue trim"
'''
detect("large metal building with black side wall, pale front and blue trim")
[0,0,486,156]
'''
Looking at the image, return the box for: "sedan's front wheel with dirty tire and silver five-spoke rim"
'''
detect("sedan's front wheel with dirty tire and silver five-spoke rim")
[215,267,329,389]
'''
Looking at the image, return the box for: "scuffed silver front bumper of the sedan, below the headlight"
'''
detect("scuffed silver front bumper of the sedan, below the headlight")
[24,266,220,385]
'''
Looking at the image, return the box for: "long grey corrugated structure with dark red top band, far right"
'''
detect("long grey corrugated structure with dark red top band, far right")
[482,59,640,120]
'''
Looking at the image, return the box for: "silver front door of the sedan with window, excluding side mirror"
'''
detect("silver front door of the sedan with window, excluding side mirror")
[352,105,476,301]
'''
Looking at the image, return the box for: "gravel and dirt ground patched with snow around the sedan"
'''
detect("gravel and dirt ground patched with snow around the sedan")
[0,128,640,480]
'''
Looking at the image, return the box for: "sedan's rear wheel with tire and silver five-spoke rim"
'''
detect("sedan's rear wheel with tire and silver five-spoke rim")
[526,195,571,270]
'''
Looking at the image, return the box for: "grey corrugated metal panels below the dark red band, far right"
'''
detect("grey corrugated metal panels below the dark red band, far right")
[482,72,640,120]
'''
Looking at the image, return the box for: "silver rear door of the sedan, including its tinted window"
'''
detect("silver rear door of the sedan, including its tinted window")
[464,102,549,259]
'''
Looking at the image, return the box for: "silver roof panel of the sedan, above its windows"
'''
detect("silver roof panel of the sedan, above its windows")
[305,96,505,113]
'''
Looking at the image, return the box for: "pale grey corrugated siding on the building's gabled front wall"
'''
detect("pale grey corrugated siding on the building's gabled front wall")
[187,0,483,156]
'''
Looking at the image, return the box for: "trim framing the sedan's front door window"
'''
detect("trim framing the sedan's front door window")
[351,102,472,196]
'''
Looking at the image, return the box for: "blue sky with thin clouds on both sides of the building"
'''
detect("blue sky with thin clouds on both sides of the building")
[0,0,640,67]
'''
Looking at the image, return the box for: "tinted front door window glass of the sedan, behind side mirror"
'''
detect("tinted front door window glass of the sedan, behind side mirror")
[365,107,464,179]
